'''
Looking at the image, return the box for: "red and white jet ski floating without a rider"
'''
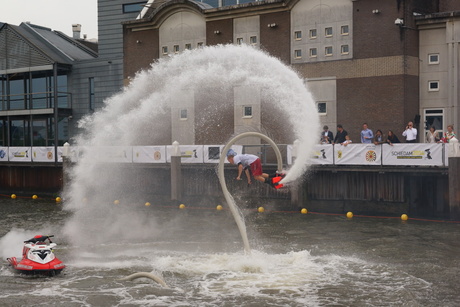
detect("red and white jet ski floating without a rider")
[7,235,65,276]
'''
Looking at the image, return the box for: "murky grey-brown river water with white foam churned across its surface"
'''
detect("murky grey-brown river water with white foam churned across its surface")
[0,198,460,306]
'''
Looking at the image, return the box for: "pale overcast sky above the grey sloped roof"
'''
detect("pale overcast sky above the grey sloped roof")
[0,0,97,39]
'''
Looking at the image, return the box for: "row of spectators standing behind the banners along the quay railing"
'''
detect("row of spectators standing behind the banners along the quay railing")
[320,121,456,146]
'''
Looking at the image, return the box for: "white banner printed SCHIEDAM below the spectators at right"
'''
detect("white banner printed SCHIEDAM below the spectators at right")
[382,143,444,166]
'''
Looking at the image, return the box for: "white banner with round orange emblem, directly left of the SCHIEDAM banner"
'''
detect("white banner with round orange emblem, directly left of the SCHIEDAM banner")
[334,143,382,165]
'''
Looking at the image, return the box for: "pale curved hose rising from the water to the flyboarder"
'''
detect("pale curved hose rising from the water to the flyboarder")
[218,132,283,254]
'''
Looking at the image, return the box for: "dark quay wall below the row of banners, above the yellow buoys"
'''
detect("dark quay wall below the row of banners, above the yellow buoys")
[0,163,452,218]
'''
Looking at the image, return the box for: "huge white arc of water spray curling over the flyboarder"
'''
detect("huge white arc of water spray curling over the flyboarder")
[65,46,319,248]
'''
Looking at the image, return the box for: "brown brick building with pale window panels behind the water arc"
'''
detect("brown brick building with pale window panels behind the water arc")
[123,0,460,142]
